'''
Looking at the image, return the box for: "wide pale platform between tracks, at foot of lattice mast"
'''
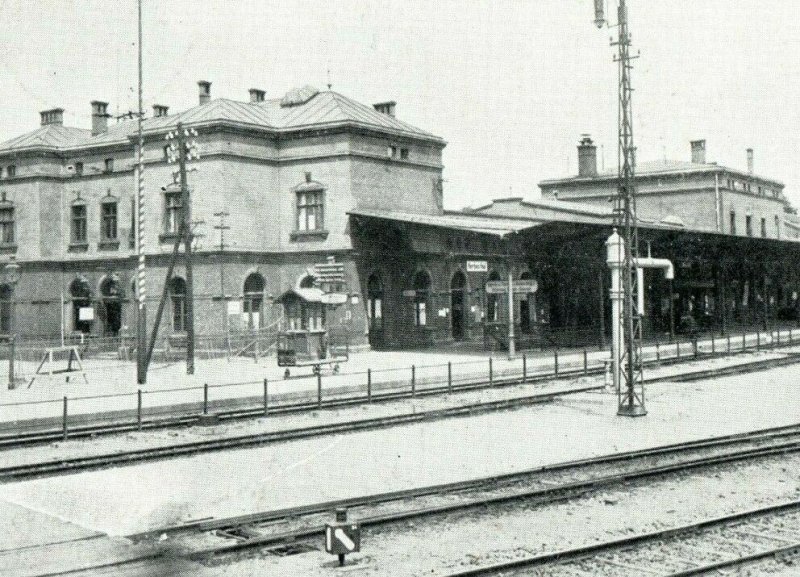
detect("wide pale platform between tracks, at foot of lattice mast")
[0,356,800,536]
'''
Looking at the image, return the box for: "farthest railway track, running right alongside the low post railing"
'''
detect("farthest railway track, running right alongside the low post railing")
[0,351,800,450]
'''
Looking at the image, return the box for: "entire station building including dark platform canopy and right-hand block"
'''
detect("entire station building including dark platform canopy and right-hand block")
[0,81,800,349]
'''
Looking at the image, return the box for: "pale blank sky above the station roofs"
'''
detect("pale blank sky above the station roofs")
[0,0,800,209]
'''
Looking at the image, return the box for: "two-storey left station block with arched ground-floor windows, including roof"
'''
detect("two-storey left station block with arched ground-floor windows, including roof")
[0,81,445,342]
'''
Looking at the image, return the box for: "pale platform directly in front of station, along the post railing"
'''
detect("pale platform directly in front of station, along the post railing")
[0,329,800,434]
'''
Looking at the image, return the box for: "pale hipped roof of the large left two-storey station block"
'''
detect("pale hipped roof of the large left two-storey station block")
[0,88,444,153]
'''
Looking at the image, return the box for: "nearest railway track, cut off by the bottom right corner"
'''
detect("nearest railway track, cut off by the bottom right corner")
[449,500,800,577]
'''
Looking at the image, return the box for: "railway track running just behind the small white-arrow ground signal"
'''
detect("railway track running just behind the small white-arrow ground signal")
[126,424,800,560]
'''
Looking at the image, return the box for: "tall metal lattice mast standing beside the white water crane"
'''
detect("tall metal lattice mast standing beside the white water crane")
[594,0,647,417]
